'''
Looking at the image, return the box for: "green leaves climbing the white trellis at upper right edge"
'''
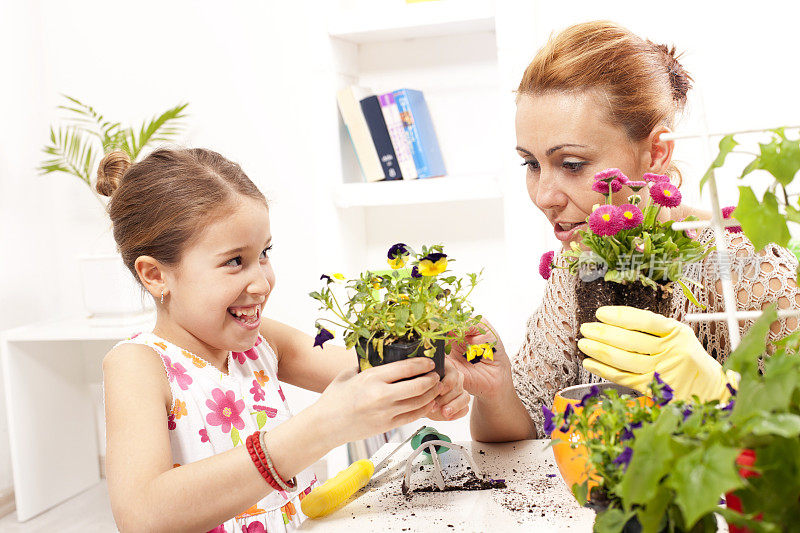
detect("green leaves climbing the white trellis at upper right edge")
[700,128,800,255]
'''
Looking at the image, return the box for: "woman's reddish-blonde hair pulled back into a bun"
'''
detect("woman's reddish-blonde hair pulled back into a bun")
[517,21,692,181]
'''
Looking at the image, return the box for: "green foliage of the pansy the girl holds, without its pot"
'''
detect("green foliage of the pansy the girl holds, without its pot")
[310,245,481,356]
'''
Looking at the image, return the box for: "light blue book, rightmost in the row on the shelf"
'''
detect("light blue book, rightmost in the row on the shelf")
[394,89,447,178]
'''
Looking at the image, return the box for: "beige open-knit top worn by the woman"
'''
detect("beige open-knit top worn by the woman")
[511,228,800,438]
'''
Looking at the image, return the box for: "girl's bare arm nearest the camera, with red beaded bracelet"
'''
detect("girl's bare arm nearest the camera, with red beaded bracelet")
[103,338,439,533]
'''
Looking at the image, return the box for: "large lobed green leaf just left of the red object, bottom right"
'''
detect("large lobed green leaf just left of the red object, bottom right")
[666,444,744,529]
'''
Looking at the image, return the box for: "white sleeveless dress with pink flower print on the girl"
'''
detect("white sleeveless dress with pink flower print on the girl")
[120,333,316,533]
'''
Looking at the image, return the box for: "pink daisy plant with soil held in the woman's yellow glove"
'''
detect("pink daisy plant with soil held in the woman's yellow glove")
[539,168,712,344]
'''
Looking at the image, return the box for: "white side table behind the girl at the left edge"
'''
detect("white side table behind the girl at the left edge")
[0,315,155,521]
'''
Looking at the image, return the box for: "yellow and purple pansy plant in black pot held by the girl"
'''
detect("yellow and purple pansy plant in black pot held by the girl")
[310,243,493,377]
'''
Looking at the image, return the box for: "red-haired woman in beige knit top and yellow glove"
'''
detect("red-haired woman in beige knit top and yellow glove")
[450,22,800,442]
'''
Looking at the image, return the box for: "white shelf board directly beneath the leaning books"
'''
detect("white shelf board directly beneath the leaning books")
[334,176,502,208]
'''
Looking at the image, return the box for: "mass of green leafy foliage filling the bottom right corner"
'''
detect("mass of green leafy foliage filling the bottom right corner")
[556,306,800,532]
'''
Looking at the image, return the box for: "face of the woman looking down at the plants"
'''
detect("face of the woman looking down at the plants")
[516,92,651,247]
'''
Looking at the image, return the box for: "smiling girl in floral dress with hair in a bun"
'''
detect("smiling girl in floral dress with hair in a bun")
[97,149,469,533]
